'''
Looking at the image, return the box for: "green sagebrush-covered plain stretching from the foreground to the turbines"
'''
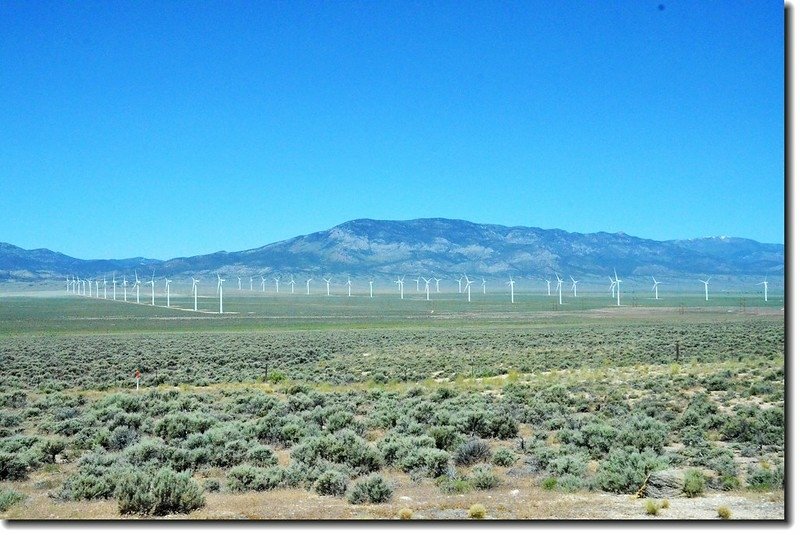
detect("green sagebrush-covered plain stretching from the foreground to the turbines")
[0,292,785,518]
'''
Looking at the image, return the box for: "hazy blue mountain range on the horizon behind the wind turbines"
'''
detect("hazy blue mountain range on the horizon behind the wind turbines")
[0,219,784,280]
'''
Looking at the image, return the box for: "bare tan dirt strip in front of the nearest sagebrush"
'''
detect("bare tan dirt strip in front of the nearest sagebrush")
[0,472,784,521]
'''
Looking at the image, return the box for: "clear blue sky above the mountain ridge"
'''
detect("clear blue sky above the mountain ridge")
[0,0,784,258]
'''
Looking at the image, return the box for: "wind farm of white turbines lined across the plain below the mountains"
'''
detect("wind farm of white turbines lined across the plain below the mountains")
[66,269,769,314]
